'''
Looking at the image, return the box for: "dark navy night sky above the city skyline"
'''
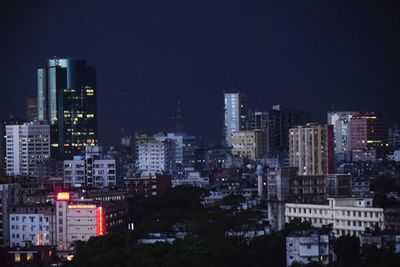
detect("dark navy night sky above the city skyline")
[0,0,400,147]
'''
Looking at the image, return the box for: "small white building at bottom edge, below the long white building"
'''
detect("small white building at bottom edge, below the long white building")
[286,230,333,267]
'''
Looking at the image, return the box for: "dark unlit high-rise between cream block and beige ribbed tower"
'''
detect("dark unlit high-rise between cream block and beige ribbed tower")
[268,105,310,158]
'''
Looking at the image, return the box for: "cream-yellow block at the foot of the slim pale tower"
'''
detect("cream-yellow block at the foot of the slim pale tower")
[231,130,267,161]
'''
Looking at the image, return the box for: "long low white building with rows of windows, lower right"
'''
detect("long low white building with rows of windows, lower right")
[285,198,385,236]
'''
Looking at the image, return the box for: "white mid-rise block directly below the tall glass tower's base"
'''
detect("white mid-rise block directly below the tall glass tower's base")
[64,147,117,188]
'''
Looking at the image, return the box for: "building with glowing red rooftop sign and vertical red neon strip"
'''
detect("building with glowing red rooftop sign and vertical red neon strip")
[55,192,106,251]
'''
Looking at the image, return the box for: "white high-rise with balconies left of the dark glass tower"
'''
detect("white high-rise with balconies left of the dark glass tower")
[6,121,50,177]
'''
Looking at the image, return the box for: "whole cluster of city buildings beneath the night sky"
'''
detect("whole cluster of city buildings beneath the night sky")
[0,59,400,266]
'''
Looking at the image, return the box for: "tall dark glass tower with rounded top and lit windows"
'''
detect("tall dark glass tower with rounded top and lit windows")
[37,59,97,159]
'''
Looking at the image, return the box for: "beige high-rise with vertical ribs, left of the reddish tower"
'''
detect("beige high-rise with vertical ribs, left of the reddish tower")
[289,123,334,175]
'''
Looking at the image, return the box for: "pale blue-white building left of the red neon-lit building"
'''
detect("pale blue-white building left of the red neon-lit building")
[9,205,55,247]
